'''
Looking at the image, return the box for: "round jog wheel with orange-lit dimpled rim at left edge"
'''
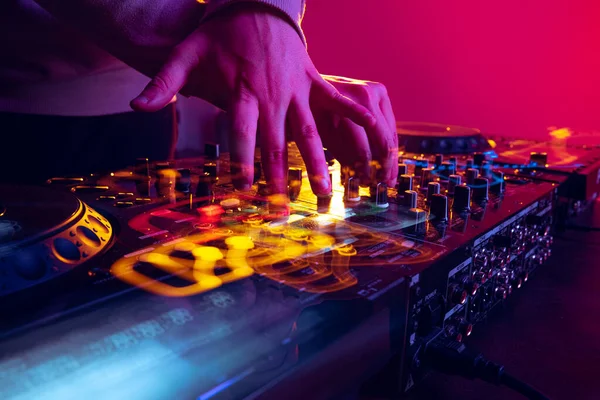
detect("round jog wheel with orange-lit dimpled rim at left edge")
[0,185,113,296]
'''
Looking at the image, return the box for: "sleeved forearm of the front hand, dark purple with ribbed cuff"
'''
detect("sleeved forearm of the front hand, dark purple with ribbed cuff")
[35,0,304,76]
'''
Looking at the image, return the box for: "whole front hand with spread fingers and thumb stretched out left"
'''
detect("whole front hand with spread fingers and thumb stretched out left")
[132,5,375,194]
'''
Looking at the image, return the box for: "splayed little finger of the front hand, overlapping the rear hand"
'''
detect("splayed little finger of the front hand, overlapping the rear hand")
[314,75,376,128]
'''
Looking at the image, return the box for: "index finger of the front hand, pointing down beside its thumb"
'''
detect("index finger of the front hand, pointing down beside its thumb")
[228,91,258,190]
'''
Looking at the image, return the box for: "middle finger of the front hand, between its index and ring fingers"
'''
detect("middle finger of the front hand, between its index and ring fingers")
[258,109,287,194]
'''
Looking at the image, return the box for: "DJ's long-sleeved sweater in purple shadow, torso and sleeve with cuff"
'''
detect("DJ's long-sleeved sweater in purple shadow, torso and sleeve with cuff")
[0,0,305,116]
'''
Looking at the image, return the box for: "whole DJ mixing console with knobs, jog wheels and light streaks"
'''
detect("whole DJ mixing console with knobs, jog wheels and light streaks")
[0,123,596,399]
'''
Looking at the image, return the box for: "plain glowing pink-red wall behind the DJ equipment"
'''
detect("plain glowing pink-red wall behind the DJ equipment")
[303,0,600,137]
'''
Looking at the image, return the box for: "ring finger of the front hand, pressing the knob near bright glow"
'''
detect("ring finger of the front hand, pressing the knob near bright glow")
[288,100,331,196]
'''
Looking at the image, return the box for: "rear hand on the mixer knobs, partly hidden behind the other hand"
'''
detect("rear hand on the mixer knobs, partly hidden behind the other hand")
[311,75,398,187]
